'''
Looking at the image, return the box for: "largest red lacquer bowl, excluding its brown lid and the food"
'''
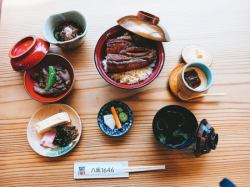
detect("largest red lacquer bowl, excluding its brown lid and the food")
[94,25,165,89]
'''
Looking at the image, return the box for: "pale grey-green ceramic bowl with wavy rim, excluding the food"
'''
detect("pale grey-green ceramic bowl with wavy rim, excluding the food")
[43,11,87,49]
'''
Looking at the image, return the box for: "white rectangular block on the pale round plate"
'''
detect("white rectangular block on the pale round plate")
[35,112,70,134]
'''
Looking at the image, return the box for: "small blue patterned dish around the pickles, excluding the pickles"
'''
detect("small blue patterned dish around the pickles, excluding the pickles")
[97,101,133,137]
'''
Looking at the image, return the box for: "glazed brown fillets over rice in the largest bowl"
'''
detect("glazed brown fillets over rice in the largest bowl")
[103,32,157,84]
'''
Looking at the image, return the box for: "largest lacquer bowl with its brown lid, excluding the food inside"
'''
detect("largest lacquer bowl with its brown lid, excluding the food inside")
[94,11,170,89]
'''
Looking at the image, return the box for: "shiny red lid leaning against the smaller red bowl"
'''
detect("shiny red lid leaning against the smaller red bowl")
[9,36,50,71]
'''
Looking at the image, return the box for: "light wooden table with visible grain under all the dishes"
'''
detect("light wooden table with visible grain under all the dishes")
[0,0,250,187]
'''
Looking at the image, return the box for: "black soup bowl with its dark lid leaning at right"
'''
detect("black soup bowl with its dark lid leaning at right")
[153,105,218,156]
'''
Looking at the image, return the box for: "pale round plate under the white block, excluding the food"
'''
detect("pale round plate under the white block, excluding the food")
[27,104,82,157]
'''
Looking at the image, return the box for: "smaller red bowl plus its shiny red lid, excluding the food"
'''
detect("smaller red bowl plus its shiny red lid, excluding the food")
[9,36,74,103]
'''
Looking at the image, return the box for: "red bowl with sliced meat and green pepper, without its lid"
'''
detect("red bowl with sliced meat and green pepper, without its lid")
[24,53,74,103]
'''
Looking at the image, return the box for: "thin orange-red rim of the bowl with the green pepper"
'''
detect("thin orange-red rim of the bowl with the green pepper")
[24,53,75,103]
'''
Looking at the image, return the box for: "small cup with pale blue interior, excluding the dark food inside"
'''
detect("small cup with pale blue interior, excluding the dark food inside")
[177,62,213,100]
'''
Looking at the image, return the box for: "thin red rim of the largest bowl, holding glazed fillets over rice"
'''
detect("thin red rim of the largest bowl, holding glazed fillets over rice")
[94,25,165,90]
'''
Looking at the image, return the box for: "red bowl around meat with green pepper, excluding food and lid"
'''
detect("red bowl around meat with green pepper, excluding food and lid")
[24,53,75,103]
